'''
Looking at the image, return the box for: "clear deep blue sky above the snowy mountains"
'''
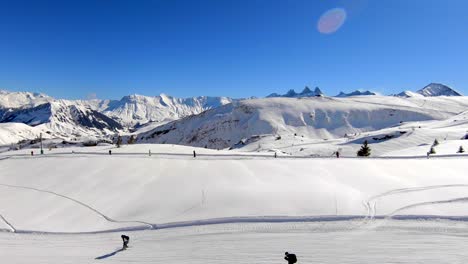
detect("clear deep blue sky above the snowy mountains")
[0,0,468,99]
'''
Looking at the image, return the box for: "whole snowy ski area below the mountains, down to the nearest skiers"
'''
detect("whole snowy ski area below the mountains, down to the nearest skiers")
[0,142,468,263]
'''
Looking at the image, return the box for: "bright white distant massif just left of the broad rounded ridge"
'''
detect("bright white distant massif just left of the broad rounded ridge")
[101,94,233,126]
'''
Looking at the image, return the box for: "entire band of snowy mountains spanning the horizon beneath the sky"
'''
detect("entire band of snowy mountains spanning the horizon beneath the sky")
[0,83,467,148]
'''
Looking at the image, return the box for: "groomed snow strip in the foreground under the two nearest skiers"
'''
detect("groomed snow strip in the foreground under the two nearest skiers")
[0,221,468,264]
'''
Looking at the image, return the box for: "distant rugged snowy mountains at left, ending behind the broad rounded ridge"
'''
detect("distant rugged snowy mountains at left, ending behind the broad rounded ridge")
[0,90,233,139]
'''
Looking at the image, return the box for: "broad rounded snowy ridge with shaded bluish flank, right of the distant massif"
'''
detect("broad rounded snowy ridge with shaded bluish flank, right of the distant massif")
[138,96,468,149]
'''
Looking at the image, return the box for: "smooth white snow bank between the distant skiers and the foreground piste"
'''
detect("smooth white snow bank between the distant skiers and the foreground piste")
[0,144,468,233]
